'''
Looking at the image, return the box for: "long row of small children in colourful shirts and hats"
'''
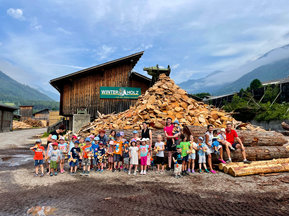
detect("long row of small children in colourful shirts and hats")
[30,127,231,178]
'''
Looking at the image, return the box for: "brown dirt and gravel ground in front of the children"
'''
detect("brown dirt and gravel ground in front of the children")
[0,129,289,215]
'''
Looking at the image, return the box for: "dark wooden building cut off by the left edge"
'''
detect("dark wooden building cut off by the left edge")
[0,104,17,132]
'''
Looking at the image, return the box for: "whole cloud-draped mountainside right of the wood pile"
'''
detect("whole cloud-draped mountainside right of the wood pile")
[179,45,289,95]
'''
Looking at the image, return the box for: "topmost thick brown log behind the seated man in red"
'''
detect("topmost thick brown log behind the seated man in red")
[183,126,288,146]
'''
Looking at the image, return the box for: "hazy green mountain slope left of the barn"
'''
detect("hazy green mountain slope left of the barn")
[0,71,54,102]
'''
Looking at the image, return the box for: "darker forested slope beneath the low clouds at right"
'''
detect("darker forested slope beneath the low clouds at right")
[215,58,289,95]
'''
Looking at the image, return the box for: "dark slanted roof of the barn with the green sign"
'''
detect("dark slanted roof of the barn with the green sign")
[50,51,144,90]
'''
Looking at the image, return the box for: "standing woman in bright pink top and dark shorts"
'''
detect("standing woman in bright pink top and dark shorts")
[164,118,175,169]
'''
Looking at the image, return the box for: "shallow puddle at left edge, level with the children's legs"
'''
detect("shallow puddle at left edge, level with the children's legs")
[0,154,33,167]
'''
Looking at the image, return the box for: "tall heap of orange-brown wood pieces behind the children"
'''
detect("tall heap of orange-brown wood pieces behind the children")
[79,74,260,134]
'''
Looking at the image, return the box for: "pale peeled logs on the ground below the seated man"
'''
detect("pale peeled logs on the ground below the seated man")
[219,158,289,176]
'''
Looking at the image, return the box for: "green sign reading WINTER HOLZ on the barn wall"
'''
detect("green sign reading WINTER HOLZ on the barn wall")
[99,87,141,99]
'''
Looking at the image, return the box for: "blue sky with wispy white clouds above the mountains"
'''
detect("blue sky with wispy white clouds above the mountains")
[0,0,289,96]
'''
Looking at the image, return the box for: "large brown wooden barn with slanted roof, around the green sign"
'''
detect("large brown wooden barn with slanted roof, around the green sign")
[50,52,151,118]
